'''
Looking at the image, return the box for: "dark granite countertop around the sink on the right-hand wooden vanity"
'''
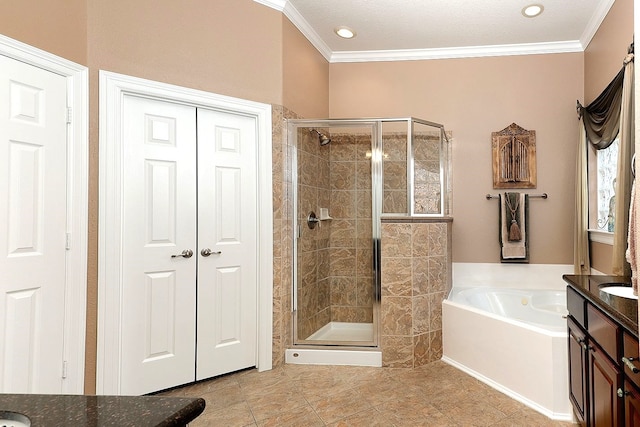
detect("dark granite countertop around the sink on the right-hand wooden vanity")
[562,274,638,338]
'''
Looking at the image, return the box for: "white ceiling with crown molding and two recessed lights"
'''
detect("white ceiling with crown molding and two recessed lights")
[254,0,615,62]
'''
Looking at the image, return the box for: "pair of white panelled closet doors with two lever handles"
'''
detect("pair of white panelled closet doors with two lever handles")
[120,96,257,394]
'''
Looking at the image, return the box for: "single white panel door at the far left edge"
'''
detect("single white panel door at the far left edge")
[0,56,67,393]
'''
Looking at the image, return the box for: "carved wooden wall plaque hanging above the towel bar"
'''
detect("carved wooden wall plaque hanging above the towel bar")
[491,123,537,188]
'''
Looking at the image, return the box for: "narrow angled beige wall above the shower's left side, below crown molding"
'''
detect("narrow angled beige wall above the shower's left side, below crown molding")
[282,18,329,119]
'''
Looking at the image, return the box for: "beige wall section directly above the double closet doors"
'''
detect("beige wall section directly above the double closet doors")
[88,0,283,103]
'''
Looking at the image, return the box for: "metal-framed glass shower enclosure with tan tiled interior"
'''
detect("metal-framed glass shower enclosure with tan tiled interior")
[287,118,450,350]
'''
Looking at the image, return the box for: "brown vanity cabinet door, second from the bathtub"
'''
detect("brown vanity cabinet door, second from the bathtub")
[588,344,624,427]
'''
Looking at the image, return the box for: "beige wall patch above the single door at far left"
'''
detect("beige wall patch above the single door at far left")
[0,0,87,65]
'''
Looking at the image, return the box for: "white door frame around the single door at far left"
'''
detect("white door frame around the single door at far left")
[0,34,89,394]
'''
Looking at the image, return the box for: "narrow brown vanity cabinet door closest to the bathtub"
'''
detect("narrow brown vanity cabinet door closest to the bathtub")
[567,316,592,427]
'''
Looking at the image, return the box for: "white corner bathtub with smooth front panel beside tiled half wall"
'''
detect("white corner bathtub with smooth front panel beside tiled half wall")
[442,264,573,421]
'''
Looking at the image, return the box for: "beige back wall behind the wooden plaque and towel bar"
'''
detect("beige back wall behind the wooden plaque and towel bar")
[329,53,583,264]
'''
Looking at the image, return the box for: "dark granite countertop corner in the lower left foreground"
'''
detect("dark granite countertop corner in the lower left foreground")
[0,394,205,427]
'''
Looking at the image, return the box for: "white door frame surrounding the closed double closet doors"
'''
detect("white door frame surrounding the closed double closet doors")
[96,70,273,395]
